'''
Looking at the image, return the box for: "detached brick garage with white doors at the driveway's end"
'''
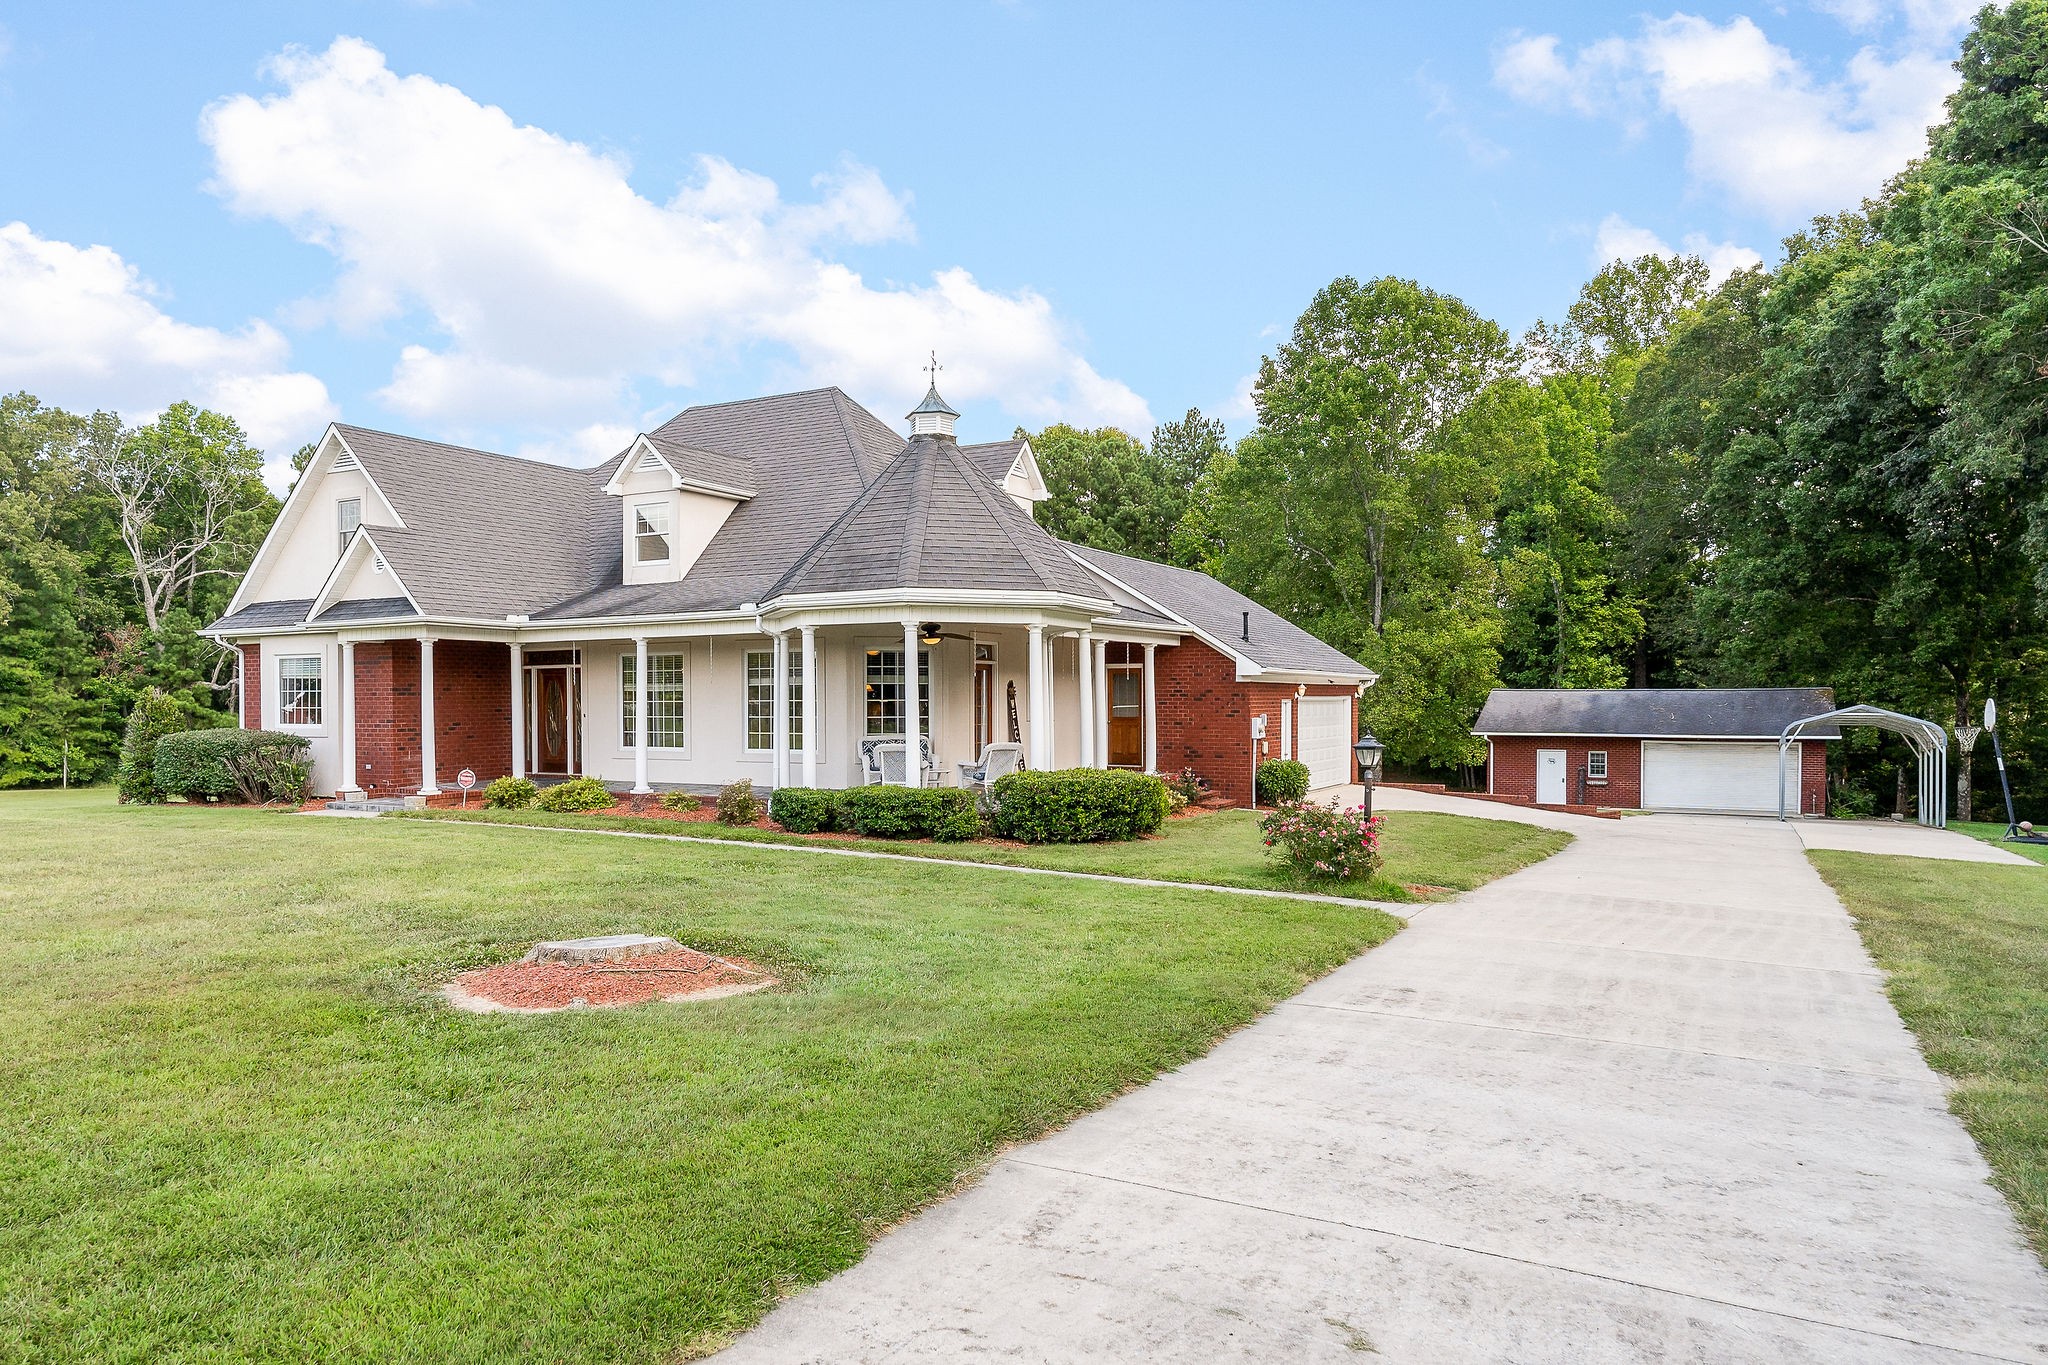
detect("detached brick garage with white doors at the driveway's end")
[1473,688,1841,814]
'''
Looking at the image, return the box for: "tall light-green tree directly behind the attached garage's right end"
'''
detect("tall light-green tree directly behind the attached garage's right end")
[1196,278,1513,765]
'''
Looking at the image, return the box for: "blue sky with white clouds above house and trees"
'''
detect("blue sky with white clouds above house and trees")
[0,0,1968,485]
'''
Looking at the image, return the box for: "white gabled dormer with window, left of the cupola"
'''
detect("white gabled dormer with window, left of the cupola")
[604,436,754,583]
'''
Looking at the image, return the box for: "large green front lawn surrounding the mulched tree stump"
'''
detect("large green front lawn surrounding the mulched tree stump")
[0,792,1397,1363]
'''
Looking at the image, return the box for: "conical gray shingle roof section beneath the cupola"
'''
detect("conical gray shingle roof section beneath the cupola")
[770,436,1106,598]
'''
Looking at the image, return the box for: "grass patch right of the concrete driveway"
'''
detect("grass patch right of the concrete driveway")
[1808,855,2048,1263]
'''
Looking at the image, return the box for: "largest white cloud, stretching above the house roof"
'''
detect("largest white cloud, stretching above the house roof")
[201,39,1151,444]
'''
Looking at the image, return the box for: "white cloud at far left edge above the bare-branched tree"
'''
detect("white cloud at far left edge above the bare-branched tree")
[0,223,336,485]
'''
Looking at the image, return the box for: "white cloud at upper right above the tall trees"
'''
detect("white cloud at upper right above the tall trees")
[1493,11,1956,223]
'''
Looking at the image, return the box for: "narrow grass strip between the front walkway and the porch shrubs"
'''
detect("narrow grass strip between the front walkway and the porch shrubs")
[408,810,1571,902]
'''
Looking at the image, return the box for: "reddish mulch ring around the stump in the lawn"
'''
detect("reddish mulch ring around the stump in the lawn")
[442,948,776,1015]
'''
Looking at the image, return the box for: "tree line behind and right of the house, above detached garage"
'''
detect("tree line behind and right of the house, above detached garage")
[1030,0,2048,817]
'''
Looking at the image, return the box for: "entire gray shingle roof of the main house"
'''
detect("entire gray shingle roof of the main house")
[211,389,1364,677]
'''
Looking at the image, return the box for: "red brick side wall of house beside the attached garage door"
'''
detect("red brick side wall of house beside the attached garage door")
[1153,636,1358,806]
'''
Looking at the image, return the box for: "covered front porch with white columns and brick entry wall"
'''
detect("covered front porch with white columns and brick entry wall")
[290,606,1180,798]
